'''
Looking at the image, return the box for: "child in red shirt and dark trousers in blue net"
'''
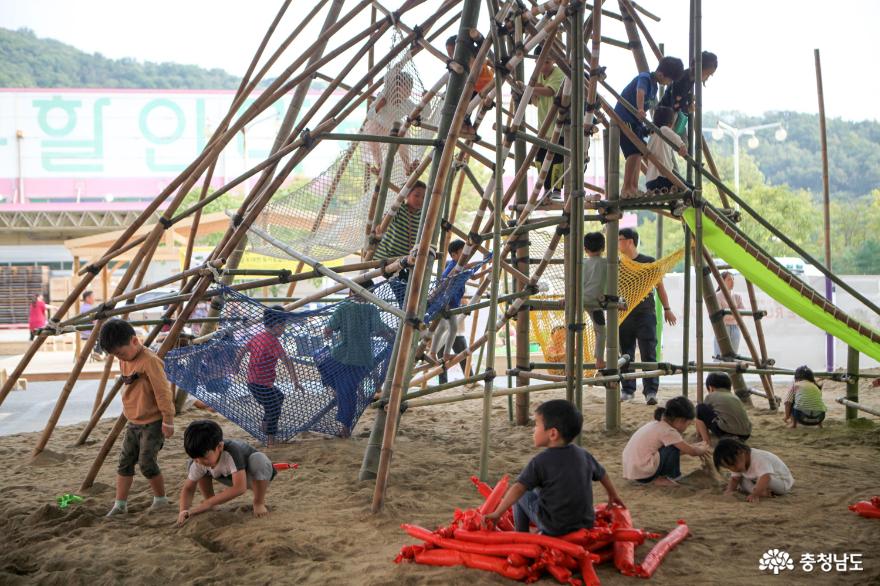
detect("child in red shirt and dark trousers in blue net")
[238,305,303,445]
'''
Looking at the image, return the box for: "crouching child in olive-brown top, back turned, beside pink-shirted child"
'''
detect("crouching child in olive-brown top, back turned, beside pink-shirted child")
[695,372,752,444]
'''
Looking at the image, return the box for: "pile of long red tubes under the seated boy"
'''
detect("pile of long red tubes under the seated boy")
[394,476,688,586]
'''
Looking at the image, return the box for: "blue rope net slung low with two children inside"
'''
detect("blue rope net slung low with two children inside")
[165,267,478,442]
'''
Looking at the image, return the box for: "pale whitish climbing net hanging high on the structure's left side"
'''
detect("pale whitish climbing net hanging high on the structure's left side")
[250,32,440,260]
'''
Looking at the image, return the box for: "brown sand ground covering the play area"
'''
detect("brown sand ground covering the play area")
[0,376,880,585]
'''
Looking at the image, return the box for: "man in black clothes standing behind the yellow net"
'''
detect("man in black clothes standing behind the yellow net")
[617,228,677,405]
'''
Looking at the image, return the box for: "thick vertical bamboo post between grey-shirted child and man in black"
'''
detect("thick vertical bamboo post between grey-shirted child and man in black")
[605,122,620,431]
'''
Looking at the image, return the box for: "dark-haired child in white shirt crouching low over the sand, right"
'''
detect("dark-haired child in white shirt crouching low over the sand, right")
[713,438,794,503]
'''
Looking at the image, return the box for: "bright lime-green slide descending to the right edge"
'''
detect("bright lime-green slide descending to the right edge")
[684,209,880,360]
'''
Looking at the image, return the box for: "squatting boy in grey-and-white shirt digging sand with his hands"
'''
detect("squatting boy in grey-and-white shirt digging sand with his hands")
[177,419,275,527]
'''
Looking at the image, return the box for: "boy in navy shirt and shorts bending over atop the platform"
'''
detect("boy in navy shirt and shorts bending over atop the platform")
[614,57,684,197]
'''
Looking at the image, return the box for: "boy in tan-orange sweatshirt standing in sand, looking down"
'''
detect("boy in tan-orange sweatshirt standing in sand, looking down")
[100,319,174,517]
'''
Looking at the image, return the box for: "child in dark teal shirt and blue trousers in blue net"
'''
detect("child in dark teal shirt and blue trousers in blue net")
[318,282,394,437]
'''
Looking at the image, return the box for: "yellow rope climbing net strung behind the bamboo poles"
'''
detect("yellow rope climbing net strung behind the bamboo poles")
[529,232,684,375]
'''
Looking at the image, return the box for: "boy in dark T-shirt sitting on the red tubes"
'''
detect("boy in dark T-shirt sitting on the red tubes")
[486,399,624,535]
